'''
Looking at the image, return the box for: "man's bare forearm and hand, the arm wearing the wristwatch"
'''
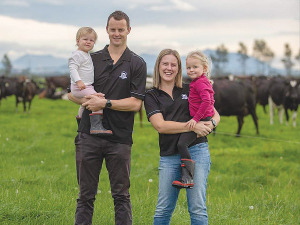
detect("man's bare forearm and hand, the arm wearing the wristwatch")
[82,95,142,112]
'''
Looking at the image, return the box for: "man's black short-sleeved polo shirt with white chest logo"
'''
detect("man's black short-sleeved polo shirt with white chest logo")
[78,45,147,145]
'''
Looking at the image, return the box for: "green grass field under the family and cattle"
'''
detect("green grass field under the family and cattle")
[0,97,300,225]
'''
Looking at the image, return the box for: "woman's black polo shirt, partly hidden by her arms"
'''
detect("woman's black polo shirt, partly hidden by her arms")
[145,84,207,156]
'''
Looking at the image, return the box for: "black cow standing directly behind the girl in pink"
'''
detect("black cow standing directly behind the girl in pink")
[213,80,259,137]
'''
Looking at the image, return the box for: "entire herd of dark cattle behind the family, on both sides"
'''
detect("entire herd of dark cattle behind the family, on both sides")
[0,76,300,136]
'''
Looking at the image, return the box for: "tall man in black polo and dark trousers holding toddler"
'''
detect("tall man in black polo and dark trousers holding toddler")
[69,11,147,225]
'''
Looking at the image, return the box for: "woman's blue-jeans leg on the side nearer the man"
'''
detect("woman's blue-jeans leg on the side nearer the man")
[153,155,181,225]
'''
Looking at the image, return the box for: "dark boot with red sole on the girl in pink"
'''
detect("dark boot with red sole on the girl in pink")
[172,159,195,189]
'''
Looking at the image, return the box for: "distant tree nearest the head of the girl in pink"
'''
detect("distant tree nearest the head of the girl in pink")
[210,44,228,77]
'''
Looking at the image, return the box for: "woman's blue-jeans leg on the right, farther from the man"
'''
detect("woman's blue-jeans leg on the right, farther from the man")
[187,142,211,225]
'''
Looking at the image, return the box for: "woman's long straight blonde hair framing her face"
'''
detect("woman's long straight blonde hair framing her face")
[153,49,182,88]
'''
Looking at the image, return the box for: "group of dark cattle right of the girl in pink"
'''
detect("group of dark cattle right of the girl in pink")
[213,76,300,136]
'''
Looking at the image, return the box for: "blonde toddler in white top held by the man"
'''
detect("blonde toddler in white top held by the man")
[69,27,112,135]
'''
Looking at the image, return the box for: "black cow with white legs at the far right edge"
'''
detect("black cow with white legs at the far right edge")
[269,77,300,127]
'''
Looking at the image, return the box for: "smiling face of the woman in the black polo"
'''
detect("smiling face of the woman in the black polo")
[159,55,178,83]
